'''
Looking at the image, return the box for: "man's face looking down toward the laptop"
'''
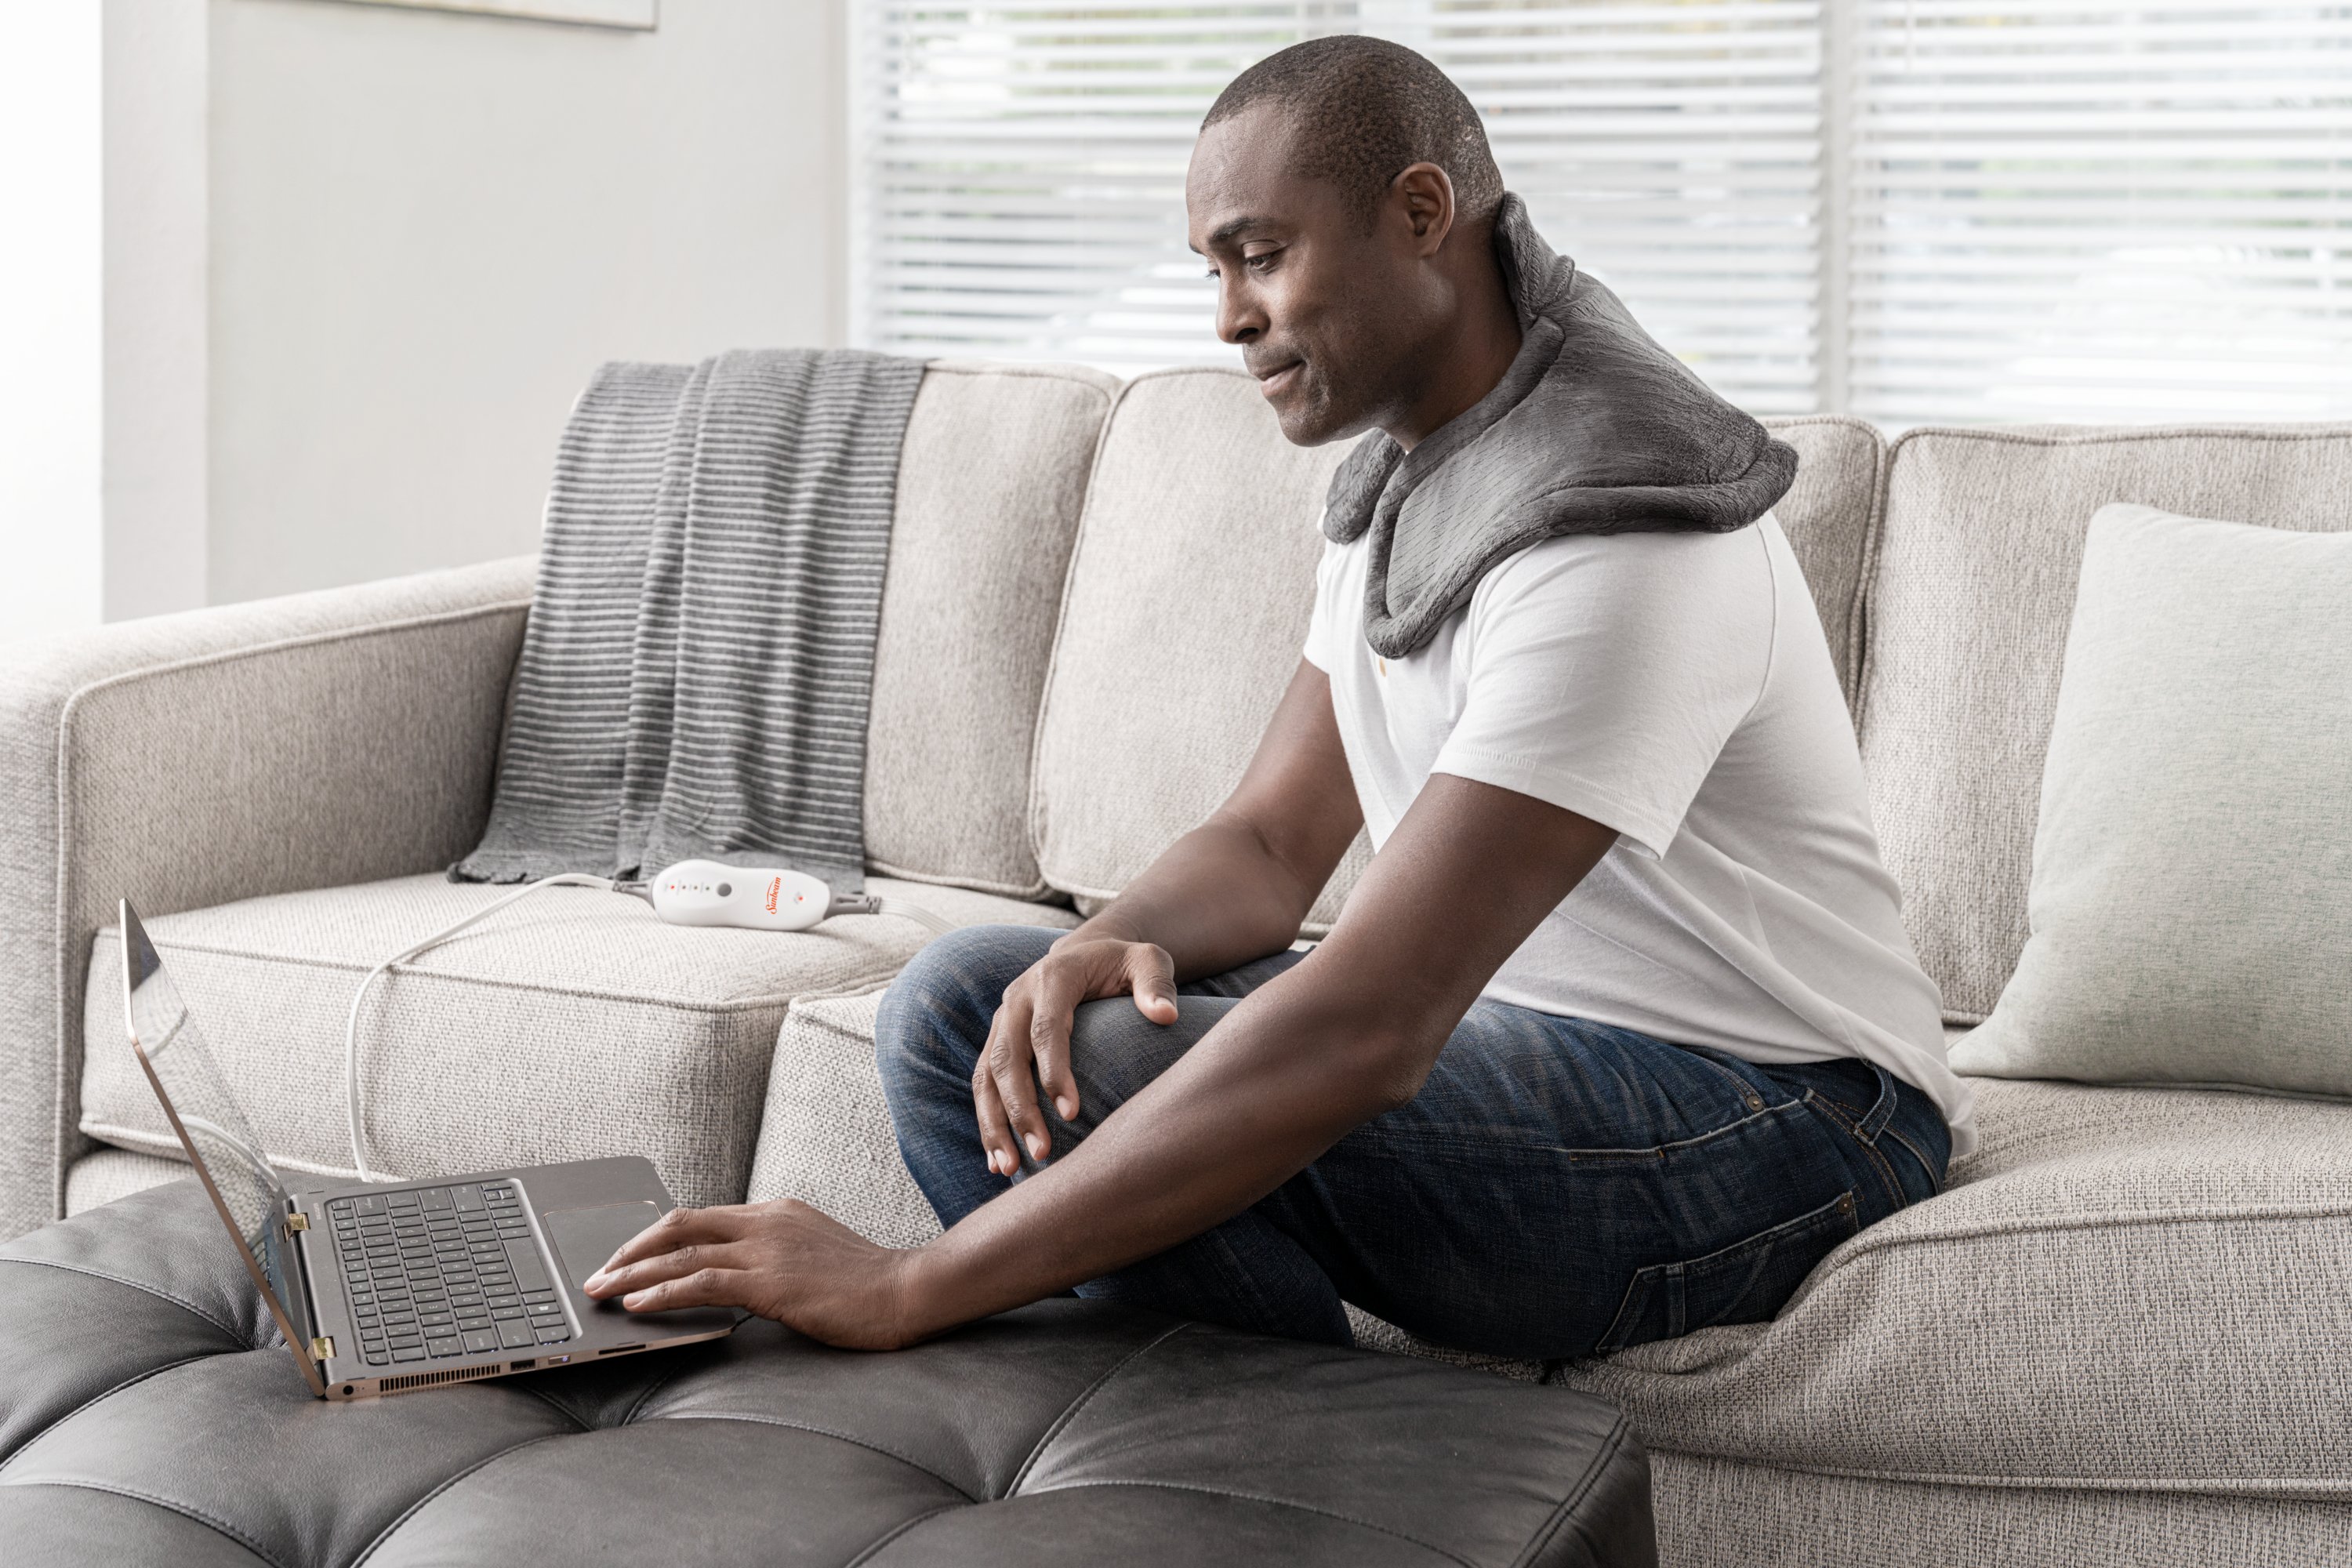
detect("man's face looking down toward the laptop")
[1185,106,1425,447]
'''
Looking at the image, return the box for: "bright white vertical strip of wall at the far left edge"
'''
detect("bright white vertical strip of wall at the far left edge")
[0,2,103,640]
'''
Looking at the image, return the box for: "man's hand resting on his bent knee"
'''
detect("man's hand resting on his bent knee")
[971,933,1176,1175]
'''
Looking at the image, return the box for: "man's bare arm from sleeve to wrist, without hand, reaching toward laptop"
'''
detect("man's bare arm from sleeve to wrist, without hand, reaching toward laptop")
[884,774,1616,1338]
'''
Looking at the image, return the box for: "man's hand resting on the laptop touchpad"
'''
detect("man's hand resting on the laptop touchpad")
[586,1199,924,1349]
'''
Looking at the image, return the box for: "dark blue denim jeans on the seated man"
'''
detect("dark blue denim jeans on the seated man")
[875,926,1950,1359]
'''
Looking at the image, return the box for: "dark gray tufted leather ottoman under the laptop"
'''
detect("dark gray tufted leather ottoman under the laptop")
[0,1182,1656,1568]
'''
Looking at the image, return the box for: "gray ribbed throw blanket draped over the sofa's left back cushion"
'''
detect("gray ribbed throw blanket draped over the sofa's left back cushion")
[449,350,922,893]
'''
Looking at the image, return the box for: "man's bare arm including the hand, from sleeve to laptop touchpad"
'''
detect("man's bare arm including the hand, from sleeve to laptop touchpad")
[590,662,1616,1345]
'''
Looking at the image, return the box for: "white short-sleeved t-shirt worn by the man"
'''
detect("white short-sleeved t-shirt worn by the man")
[1305,515,1976,1154]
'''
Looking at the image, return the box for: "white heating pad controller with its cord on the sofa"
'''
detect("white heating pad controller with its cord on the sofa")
[343,860,955,1182]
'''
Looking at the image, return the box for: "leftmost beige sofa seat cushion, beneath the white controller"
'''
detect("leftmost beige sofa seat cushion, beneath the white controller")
[82,877,1075,1203]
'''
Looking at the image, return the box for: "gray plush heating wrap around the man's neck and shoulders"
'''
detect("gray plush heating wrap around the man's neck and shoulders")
[1324,195,1797,659]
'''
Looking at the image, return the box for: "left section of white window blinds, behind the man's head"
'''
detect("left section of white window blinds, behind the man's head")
[854,0,1820,409]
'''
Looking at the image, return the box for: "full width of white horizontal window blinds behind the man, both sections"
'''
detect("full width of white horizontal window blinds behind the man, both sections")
[851,0,2352,426]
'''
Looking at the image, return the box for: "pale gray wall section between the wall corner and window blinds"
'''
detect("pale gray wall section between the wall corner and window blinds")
[202,0,847,602]
